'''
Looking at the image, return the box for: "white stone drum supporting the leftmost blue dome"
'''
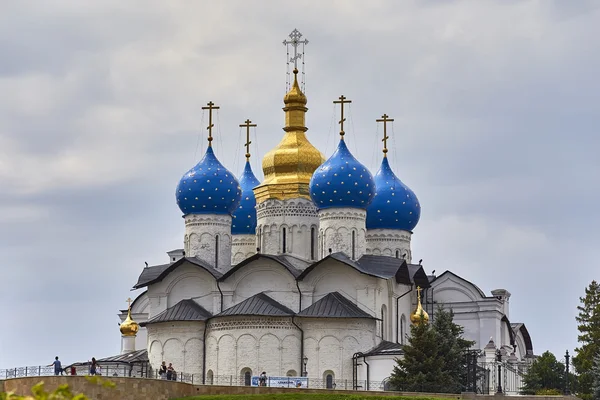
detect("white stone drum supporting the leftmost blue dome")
[184,214,231,272]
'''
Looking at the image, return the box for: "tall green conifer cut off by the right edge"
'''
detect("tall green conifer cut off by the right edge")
[573,281,600,399]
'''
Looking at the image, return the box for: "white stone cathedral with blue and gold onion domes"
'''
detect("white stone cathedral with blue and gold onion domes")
[119,32,533,387]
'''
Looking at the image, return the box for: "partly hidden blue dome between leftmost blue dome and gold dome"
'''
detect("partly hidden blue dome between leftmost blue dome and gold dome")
[231,161,260,235]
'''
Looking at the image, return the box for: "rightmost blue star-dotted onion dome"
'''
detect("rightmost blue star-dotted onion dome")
[367,157,421,232]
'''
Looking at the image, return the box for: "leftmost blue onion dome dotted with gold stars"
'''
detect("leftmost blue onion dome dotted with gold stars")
[175,147,242,215]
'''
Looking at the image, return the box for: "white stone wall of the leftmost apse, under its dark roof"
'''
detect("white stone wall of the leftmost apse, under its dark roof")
[147,321,204,377]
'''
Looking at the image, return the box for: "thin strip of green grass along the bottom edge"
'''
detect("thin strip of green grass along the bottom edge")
[169,393,448,400]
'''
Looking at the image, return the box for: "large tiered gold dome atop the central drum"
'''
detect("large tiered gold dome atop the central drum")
[254,69,325,203]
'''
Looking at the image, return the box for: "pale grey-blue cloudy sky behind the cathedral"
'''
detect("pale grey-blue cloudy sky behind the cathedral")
[0,0,600,368]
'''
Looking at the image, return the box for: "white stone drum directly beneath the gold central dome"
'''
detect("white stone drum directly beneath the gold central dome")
[255,199,319,260]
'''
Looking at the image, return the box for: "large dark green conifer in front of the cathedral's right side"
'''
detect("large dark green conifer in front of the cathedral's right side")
[390,307,474,393]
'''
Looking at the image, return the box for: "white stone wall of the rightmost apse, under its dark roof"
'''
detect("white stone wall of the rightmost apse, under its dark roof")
[300,318,380,380]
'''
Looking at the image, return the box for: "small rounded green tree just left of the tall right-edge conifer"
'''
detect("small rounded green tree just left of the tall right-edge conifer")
[521,351,565,395]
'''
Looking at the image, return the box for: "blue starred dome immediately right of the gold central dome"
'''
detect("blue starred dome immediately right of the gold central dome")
[309,140,375,209]
